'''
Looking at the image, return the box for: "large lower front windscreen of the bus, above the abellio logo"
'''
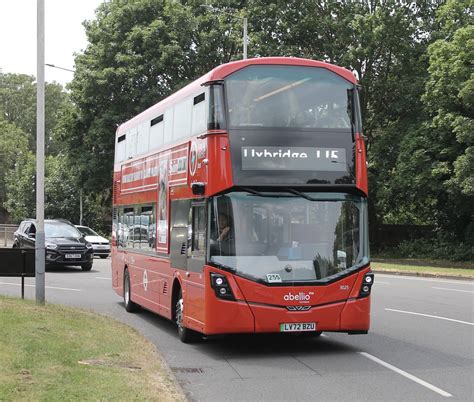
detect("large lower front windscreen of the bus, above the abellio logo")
[210,192,368,283]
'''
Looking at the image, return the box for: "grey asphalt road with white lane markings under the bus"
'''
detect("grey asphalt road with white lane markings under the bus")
[0,259,474,401]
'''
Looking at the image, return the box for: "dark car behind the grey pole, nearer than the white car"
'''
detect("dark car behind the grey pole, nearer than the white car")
[13,219,94,271]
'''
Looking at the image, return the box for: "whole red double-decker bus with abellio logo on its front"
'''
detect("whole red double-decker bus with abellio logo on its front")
[112,57,373,342]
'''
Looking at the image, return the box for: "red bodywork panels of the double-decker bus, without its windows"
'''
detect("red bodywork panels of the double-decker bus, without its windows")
[112,58,371,335]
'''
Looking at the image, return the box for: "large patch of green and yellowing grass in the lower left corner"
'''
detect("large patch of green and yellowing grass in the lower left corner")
[0,296,184,401]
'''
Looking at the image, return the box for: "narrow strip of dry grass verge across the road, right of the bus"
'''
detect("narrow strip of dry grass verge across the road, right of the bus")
[371,259,474,279]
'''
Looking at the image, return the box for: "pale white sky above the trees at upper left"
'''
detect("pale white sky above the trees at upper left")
[0,0,104,85]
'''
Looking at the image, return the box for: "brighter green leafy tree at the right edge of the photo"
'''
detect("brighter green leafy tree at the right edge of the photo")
[423,1,474,245]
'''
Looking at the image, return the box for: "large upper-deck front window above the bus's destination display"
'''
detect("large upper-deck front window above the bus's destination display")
[225,65,353,129]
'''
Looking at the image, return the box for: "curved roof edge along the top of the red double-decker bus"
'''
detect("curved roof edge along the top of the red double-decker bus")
[116,57,357,136]
